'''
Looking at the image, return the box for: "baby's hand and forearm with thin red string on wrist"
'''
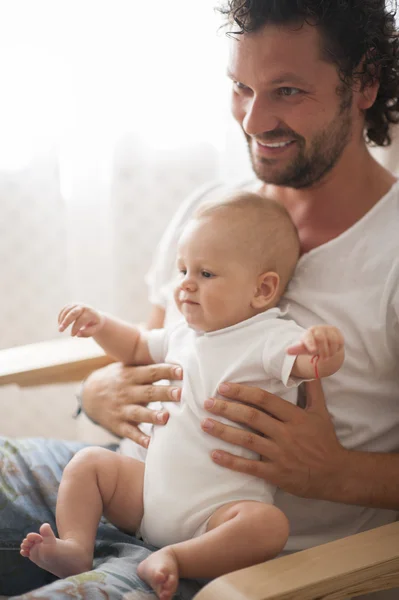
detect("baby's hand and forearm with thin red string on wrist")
[287,325,345,379]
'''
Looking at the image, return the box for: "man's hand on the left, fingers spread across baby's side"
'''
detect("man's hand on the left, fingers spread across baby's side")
[82,363,182,448]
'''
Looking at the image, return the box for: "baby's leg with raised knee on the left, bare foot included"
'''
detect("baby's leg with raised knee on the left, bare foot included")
[21,448,144,577]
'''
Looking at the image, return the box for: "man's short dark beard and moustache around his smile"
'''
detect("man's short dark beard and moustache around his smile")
[245,89,353,189]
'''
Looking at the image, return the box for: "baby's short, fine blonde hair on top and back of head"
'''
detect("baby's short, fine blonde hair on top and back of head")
[194,192,299,295]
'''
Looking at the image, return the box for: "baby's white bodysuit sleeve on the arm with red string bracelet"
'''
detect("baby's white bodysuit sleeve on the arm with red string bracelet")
[262,319,306,387]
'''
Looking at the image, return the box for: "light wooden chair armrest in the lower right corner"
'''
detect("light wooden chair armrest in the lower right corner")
[195,522,399,600]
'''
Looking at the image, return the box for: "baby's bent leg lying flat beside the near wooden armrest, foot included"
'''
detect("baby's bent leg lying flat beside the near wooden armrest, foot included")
[137,500,289,600]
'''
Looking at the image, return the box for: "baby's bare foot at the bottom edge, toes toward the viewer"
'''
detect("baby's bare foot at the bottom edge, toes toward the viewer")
[137,548,179,600]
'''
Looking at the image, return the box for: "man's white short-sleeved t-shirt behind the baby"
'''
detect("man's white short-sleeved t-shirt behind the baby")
[124,181,399,596]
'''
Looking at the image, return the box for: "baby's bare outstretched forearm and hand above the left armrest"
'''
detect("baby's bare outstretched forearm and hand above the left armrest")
[58,304,154,365]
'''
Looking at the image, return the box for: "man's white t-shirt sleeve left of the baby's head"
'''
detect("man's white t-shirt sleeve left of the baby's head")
[145,182,228,309]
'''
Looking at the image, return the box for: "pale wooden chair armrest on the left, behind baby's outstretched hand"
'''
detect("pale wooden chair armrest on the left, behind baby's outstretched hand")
[0,338,113,387]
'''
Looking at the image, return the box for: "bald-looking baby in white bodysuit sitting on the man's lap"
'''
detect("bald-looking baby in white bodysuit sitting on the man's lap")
[21,193,344,600]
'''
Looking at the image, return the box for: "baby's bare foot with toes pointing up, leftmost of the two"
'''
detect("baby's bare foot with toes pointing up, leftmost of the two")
[20,523,92,577]
